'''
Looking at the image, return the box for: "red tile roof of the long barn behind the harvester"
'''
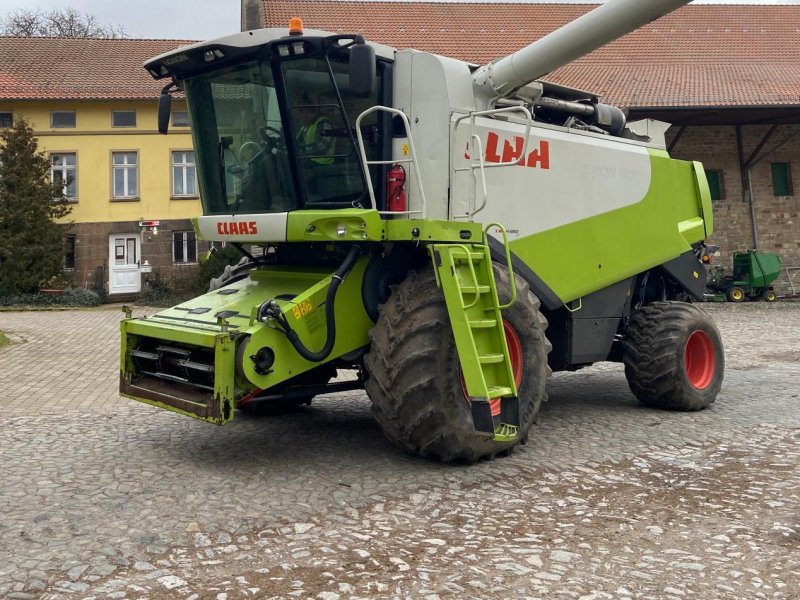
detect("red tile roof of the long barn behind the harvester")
[262,0,800,107]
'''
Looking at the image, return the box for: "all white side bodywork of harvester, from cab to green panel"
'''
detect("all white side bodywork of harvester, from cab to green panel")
[394,51,651,239]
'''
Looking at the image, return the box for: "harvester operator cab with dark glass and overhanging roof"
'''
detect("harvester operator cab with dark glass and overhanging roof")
[145,23,391,215]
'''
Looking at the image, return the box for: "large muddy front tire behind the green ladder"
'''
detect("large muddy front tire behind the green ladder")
[365,265,550,463]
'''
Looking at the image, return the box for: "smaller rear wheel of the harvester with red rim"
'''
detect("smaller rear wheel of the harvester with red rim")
[622,302,725,410]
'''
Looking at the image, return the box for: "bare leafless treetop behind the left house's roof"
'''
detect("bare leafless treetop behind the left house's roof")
[0,7,126,38]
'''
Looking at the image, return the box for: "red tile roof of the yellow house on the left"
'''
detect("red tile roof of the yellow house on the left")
[0,36,192,100]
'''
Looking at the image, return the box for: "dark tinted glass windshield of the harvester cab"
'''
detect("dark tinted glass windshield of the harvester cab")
[184,56,376,215]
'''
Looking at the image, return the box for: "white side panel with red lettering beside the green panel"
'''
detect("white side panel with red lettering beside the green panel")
[451,118,650,239]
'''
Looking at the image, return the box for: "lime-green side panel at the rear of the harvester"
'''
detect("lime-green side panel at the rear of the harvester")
[511,149,711,303]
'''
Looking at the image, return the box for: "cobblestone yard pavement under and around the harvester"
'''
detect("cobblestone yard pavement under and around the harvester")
[0,303,800,600]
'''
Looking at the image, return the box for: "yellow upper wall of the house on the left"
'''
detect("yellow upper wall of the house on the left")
[0,97,201,223]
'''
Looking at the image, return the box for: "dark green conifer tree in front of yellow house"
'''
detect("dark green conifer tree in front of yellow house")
[0,117,70,295]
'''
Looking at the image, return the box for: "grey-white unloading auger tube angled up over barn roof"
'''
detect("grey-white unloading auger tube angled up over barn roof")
[473,0,690,96]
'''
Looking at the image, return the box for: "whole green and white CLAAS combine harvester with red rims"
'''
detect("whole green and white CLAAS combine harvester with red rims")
[120,0,724,462]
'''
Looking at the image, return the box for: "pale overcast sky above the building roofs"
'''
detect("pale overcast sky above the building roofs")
[0,0,800,40]
